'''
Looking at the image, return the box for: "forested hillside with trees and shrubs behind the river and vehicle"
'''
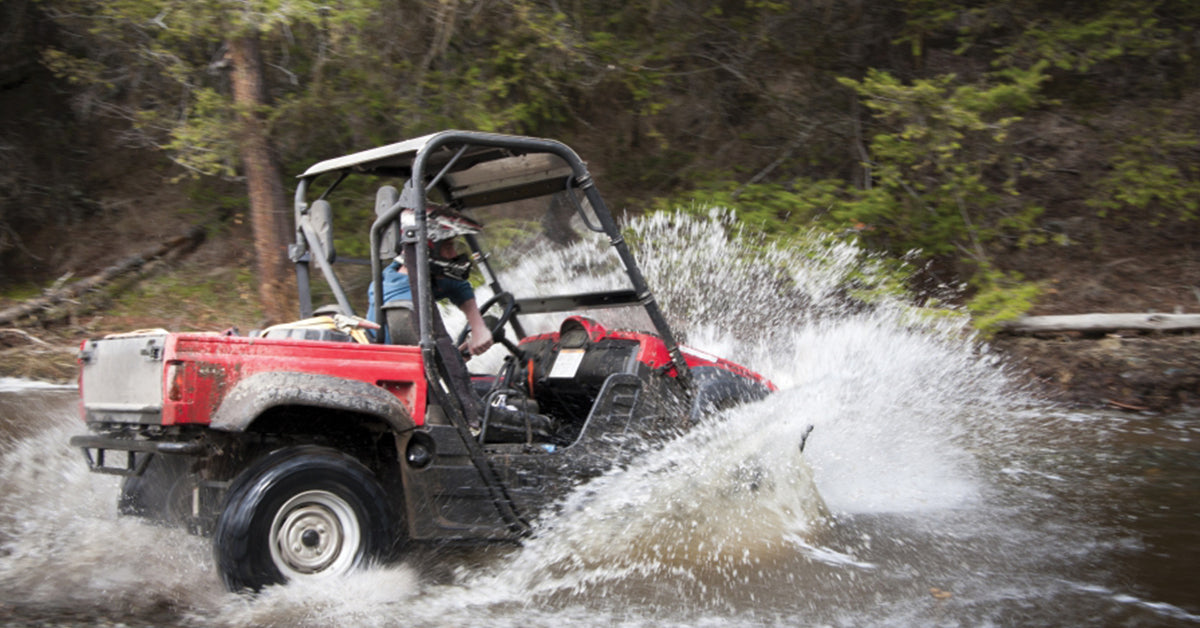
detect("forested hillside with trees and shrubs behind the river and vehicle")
[0,0,1200,408]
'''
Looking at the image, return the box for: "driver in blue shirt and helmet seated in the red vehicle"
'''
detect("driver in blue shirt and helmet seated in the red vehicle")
[367,205,492,355]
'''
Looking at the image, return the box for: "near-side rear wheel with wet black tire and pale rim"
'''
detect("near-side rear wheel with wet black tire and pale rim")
[212,445,394,591]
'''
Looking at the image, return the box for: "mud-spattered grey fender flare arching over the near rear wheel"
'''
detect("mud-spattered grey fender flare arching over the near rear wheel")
[209,371,414,432]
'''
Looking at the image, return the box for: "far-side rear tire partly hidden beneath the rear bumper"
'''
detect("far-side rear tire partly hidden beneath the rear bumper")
[116,454,196,526]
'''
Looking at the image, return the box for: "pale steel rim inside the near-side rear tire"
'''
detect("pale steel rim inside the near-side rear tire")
[270,490,362,579]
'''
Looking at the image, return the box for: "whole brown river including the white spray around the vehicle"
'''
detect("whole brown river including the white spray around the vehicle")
[0,217,1200,627]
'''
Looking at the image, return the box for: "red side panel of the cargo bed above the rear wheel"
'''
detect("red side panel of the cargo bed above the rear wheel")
[154,334,426,425]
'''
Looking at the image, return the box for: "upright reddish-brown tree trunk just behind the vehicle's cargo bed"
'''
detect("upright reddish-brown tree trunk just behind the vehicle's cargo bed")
[229,34,295,323]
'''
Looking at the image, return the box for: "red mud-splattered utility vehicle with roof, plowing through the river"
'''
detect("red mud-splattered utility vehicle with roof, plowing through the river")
[72,131,774,590]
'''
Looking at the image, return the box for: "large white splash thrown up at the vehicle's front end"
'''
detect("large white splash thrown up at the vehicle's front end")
[436,210,1014,603]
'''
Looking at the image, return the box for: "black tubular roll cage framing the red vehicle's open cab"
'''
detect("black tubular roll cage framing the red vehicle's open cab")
[288,131,690,384]
